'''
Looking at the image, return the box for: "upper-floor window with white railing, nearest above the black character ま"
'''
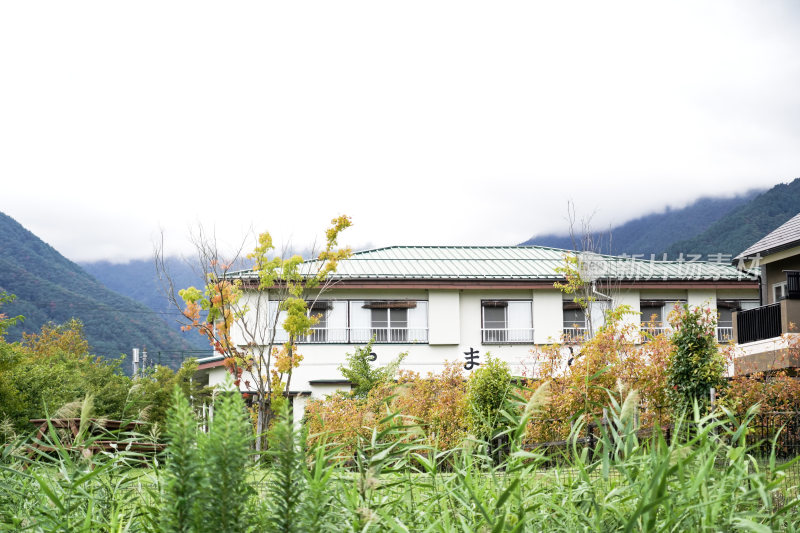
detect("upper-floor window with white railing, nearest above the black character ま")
[481,300,533,344]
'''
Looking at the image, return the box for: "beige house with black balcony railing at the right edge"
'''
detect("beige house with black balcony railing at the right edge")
[734,214,800,374]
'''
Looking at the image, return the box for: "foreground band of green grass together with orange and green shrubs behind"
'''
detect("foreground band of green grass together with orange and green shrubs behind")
[0,294,800,532]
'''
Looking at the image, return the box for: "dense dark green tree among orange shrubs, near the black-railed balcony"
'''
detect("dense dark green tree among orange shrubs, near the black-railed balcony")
[667,304,726,410]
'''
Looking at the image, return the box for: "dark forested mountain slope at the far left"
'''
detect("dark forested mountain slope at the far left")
[0,213,210,372]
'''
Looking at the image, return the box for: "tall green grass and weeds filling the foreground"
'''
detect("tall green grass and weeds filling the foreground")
[0,388,800,533]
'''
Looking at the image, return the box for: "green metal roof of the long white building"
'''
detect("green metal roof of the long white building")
[230,246,756,281]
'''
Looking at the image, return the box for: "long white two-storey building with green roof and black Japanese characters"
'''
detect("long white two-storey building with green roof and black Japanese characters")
[194,246,758,416]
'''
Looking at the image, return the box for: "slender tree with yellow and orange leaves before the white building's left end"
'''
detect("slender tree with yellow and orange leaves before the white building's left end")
[156,216,351,450]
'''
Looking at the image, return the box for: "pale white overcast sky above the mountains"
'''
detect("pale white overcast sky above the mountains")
[0,0,800,261]
